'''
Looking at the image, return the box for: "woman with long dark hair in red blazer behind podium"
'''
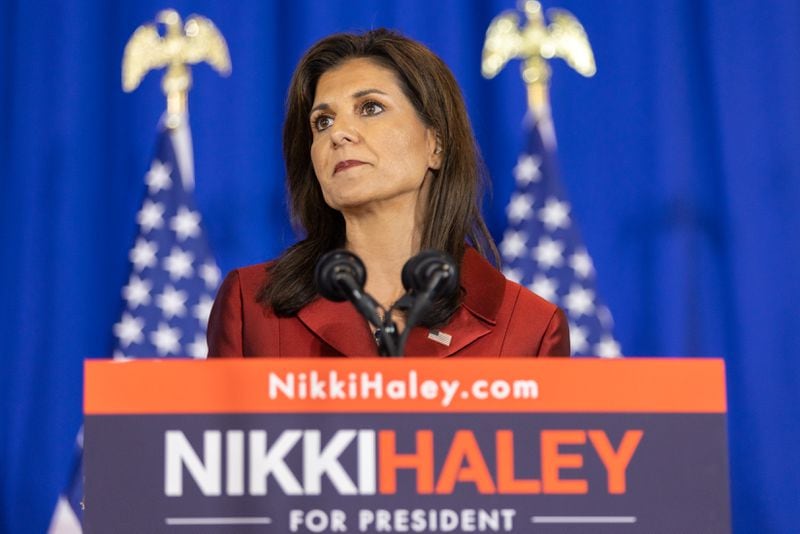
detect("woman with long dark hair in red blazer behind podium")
[208,30,569,357]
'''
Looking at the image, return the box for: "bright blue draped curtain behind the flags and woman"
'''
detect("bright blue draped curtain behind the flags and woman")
[0,0,800,533]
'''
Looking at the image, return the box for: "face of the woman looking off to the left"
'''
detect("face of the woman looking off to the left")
[309,58,441,216]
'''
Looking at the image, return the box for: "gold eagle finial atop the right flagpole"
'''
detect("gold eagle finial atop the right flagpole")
[481,0,597,114]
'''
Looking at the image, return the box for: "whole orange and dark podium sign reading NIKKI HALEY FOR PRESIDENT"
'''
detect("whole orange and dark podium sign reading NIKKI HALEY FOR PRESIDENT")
[84,358,730,534]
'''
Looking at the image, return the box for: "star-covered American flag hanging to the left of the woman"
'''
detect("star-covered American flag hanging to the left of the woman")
[49,117,220,534]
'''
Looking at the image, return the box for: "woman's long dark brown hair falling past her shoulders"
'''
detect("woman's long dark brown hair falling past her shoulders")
[258,29,499,326]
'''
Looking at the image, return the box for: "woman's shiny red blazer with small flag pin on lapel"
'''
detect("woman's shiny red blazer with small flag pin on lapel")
[208,248,569,357]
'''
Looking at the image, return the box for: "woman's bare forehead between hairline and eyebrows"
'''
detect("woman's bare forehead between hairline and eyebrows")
[314,58,402,105]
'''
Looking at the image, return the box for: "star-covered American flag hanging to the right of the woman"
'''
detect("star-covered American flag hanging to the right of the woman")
[500,115,621,357]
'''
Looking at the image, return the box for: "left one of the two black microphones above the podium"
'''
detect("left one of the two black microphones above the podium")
[314,249,381,328]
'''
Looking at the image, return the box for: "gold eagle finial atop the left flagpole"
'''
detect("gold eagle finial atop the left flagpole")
[122,9,231,125]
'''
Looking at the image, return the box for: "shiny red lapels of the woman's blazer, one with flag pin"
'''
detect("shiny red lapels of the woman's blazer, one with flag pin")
[297,248,505,357]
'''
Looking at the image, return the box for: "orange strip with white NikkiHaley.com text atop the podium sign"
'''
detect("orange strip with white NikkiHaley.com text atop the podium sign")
[84,358,726,415]
